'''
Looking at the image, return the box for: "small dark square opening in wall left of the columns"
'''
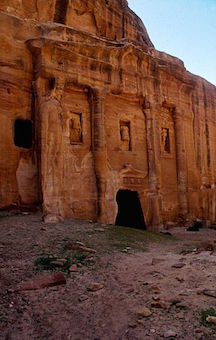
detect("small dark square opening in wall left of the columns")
[14,119,32,149]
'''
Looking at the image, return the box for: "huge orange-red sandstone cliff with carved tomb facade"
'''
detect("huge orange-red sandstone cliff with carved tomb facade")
[0,0,216,229]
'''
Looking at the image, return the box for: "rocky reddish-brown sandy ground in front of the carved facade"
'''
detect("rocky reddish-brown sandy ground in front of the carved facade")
[0,212,216,340]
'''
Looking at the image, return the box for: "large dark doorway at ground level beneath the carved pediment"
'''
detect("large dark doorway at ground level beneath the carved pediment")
[115,190,146,229]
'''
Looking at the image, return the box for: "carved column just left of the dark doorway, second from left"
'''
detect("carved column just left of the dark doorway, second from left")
[91,89,108,222]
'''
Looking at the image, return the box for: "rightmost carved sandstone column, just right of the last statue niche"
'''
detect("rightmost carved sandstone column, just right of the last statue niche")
[173,110,188,218]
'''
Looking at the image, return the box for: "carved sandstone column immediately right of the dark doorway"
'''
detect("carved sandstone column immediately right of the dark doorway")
[143,102,161,230]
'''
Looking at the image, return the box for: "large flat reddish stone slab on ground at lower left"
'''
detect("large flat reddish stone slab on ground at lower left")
[14,273,66,292]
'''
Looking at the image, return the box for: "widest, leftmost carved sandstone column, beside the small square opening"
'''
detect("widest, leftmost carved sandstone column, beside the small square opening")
[34,77,64,223]
